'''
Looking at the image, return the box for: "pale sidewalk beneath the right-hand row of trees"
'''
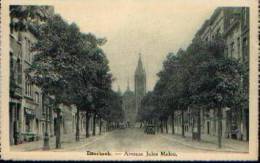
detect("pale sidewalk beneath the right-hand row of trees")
[159,133,249,153]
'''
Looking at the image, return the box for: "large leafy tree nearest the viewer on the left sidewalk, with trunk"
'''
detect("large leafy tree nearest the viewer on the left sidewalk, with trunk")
[29,15,84,148]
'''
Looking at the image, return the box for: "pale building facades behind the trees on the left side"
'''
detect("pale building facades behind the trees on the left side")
[9,7,79,145]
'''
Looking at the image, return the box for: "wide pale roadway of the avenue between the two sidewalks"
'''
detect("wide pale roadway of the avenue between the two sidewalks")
[66,128,204,152]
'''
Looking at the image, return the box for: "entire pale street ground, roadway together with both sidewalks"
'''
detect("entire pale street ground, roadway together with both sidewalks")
[11,128,248,153]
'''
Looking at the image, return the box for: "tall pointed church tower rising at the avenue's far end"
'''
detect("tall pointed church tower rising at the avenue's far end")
[135,53,146,112]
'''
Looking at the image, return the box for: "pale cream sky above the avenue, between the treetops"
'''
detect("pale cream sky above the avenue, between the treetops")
[54,0,216,92]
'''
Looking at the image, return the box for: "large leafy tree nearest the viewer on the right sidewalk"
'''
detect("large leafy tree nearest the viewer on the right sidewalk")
[186,38,245,147]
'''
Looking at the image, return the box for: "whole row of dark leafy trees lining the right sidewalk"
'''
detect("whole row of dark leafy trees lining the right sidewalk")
[140,37,243,147]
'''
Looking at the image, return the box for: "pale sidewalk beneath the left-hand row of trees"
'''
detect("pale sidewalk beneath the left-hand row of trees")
[10,132,108,152]
